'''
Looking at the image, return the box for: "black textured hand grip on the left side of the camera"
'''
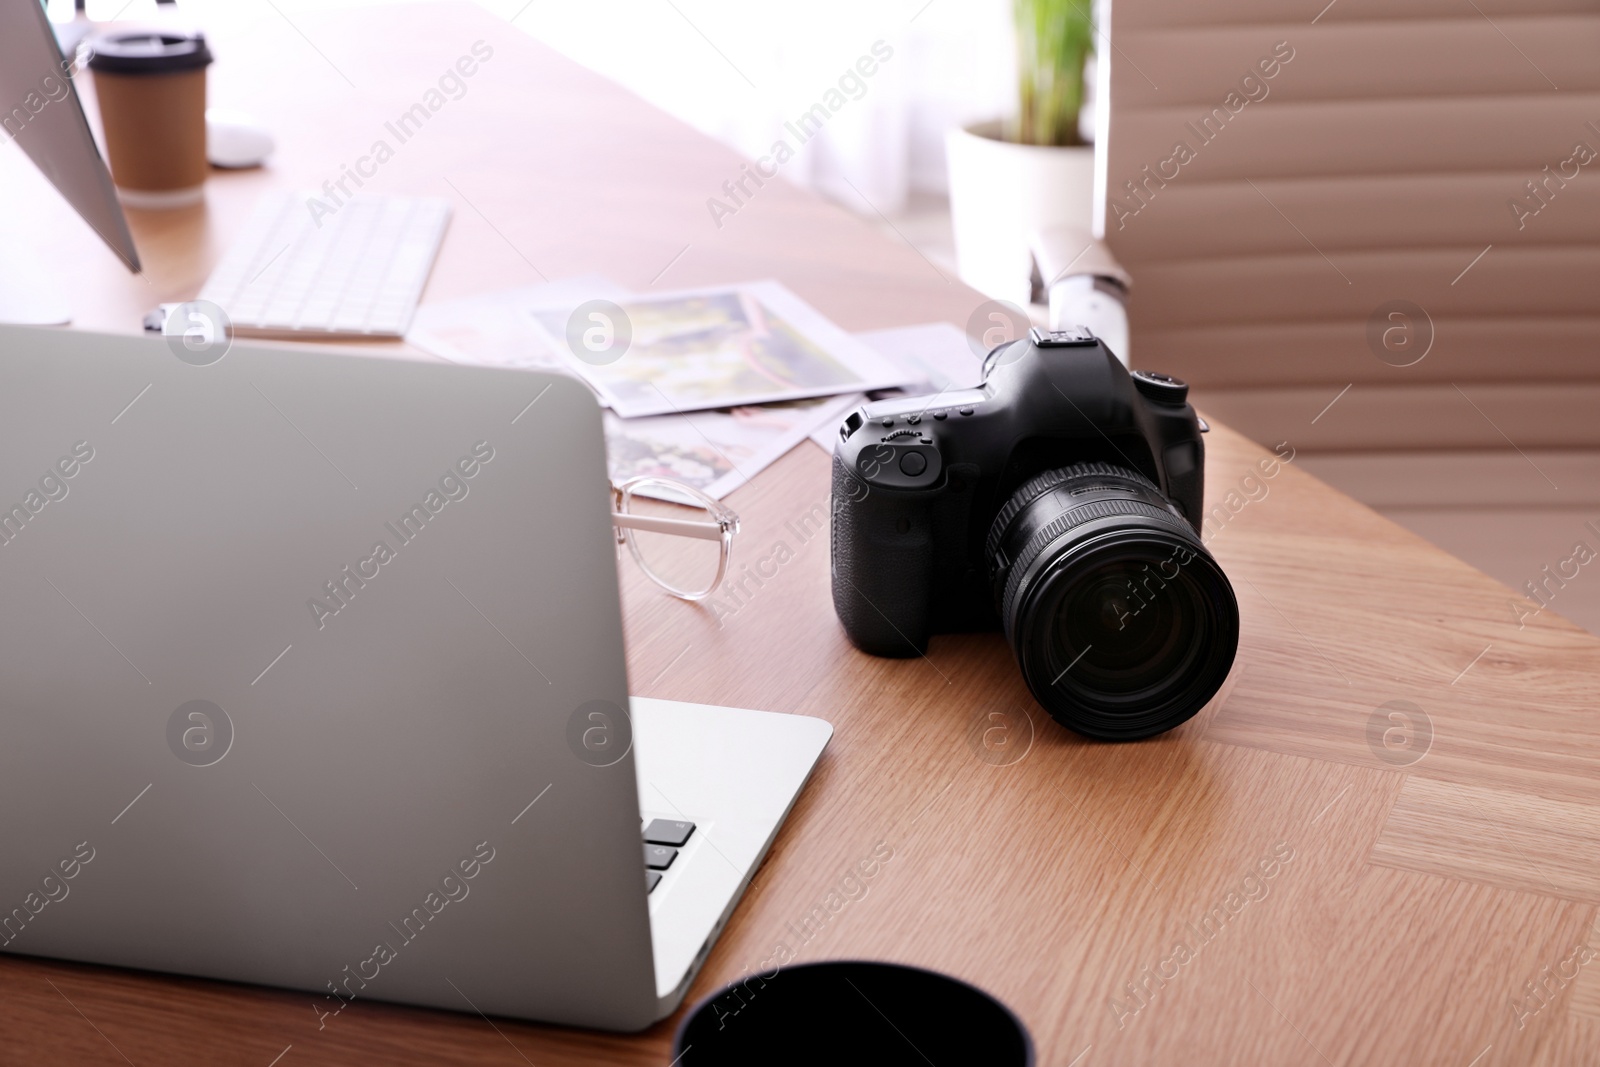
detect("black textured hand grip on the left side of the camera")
[832,456,934,657]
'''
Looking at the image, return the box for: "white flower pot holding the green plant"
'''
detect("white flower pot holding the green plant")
[944,122,1094,306]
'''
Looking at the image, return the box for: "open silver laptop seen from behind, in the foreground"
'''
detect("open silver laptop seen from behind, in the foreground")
[0,328,832,1030]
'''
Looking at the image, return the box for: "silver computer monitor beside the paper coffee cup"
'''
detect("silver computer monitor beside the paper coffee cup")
[0,0,139,322]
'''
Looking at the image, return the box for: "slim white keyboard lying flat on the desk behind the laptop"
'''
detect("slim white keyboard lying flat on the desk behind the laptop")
[200,194,450,338]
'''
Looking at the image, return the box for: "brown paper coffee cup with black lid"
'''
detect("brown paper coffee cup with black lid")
[90,30,211,208]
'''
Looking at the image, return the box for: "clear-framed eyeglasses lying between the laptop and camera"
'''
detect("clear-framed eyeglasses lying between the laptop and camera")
[611,475,739,600]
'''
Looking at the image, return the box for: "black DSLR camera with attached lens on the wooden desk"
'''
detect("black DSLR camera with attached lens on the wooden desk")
[832,326,1238,741]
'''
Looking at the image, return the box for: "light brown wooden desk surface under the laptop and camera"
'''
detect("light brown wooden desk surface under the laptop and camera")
[0,5,1600,1067]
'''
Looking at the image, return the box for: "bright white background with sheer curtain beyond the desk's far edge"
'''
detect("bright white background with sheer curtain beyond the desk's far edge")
[50,0,1016,214]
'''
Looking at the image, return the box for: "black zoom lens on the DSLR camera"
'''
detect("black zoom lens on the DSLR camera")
[987,462,1238,741]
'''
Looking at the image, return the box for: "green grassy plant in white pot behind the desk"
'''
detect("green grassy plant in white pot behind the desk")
[946,0,1094,304]
